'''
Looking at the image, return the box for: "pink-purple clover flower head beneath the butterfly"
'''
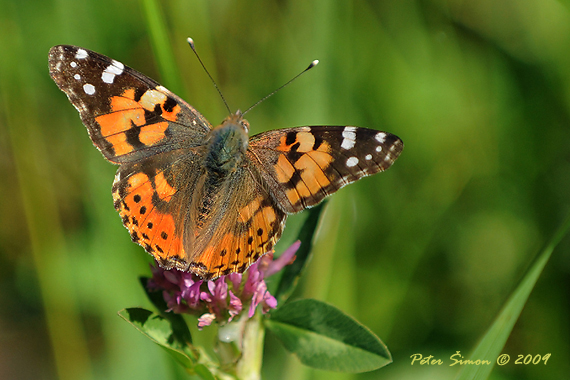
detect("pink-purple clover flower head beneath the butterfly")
[147,241,301,329]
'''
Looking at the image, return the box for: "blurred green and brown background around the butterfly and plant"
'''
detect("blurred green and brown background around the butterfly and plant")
[0,0,570,380]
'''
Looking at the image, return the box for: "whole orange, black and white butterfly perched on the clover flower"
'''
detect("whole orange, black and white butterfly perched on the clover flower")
[49,45,403,279]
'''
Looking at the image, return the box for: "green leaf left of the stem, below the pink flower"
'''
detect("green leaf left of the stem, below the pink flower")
[119,308,198,369]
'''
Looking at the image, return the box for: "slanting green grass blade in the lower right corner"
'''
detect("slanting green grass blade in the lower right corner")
[456,217,570,380]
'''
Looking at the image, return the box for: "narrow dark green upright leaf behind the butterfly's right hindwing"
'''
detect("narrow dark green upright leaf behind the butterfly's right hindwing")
[274,200,326,304]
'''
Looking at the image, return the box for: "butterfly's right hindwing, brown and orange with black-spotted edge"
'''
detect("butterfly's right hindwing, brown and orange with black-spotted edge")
[184,165,287,279]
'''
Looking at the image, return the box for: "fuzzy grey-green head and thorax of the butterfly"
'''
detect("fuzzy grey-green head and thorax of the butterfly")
[204,111,248,176]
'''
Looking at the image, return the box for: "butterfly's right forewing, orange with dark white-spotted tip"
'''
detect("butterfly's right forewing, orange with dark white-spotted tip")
[247,126,404,213]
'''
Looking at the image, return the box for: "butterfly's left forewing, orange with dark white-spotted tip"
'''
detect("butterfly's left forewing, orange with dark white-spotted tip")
[49,45,211,163]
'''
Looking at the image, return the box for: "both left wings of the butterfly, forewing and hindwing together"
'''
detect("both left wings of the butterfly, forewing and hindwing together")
[49,45,211,269]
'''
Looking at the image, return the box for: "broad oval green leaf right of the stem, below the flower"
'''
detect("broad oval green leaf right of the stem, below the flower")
[265,299,392,372]
